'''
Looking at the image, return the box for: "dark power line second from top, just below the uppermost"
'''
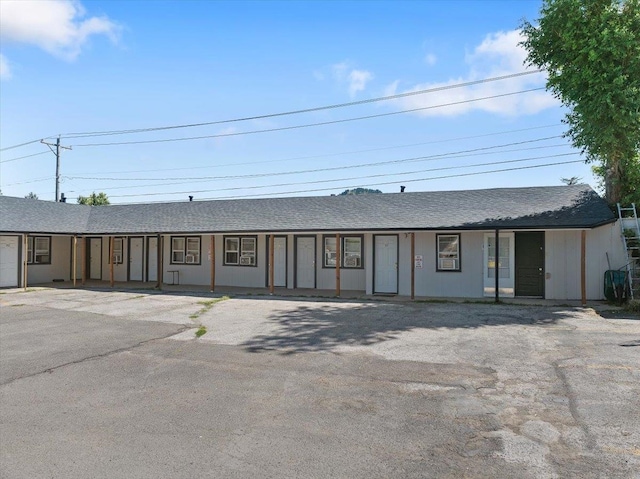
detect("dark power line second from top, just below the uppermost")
[73,87,545,147]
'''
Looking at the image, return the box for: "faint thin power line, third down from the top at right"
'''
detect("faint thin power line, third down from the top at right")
[68,123,558,178]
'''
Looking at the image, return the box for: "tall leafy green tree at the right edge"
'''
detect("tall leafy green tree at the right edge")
[521,0,640,203]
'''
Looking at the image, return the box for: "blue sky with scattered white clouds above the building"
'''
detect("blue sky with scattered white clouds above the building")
[0,0,597,203]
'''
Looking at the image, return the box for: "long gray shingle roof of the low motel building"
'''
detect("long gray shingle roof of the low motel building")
[0,185,615,234]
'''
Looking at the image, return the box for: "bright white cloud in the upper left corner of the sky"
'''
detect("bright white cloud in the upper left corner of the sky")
[0,0,120,61]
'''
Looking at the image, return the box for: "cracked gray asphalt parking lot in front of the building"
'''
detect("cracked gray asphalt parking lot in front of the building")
[0,289,640,478]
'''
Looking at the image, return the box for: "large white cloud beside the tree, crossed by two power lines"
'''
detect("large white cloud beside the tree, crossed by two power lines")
[386,30,558,116]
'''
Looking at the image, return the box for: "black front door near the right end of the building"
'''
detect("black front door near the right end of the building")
[516,231,544,298]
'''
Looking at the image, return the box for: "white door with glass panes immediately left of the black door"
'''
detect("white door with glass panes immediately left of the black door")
[483,233,515,297]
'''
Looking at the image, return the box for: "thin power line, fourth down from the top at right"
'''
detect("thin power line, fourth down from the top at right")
[68,135,565,186]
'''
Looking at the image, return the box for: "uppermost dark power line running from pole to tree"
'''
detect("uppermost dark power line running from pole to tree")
[63,70,543,141]
